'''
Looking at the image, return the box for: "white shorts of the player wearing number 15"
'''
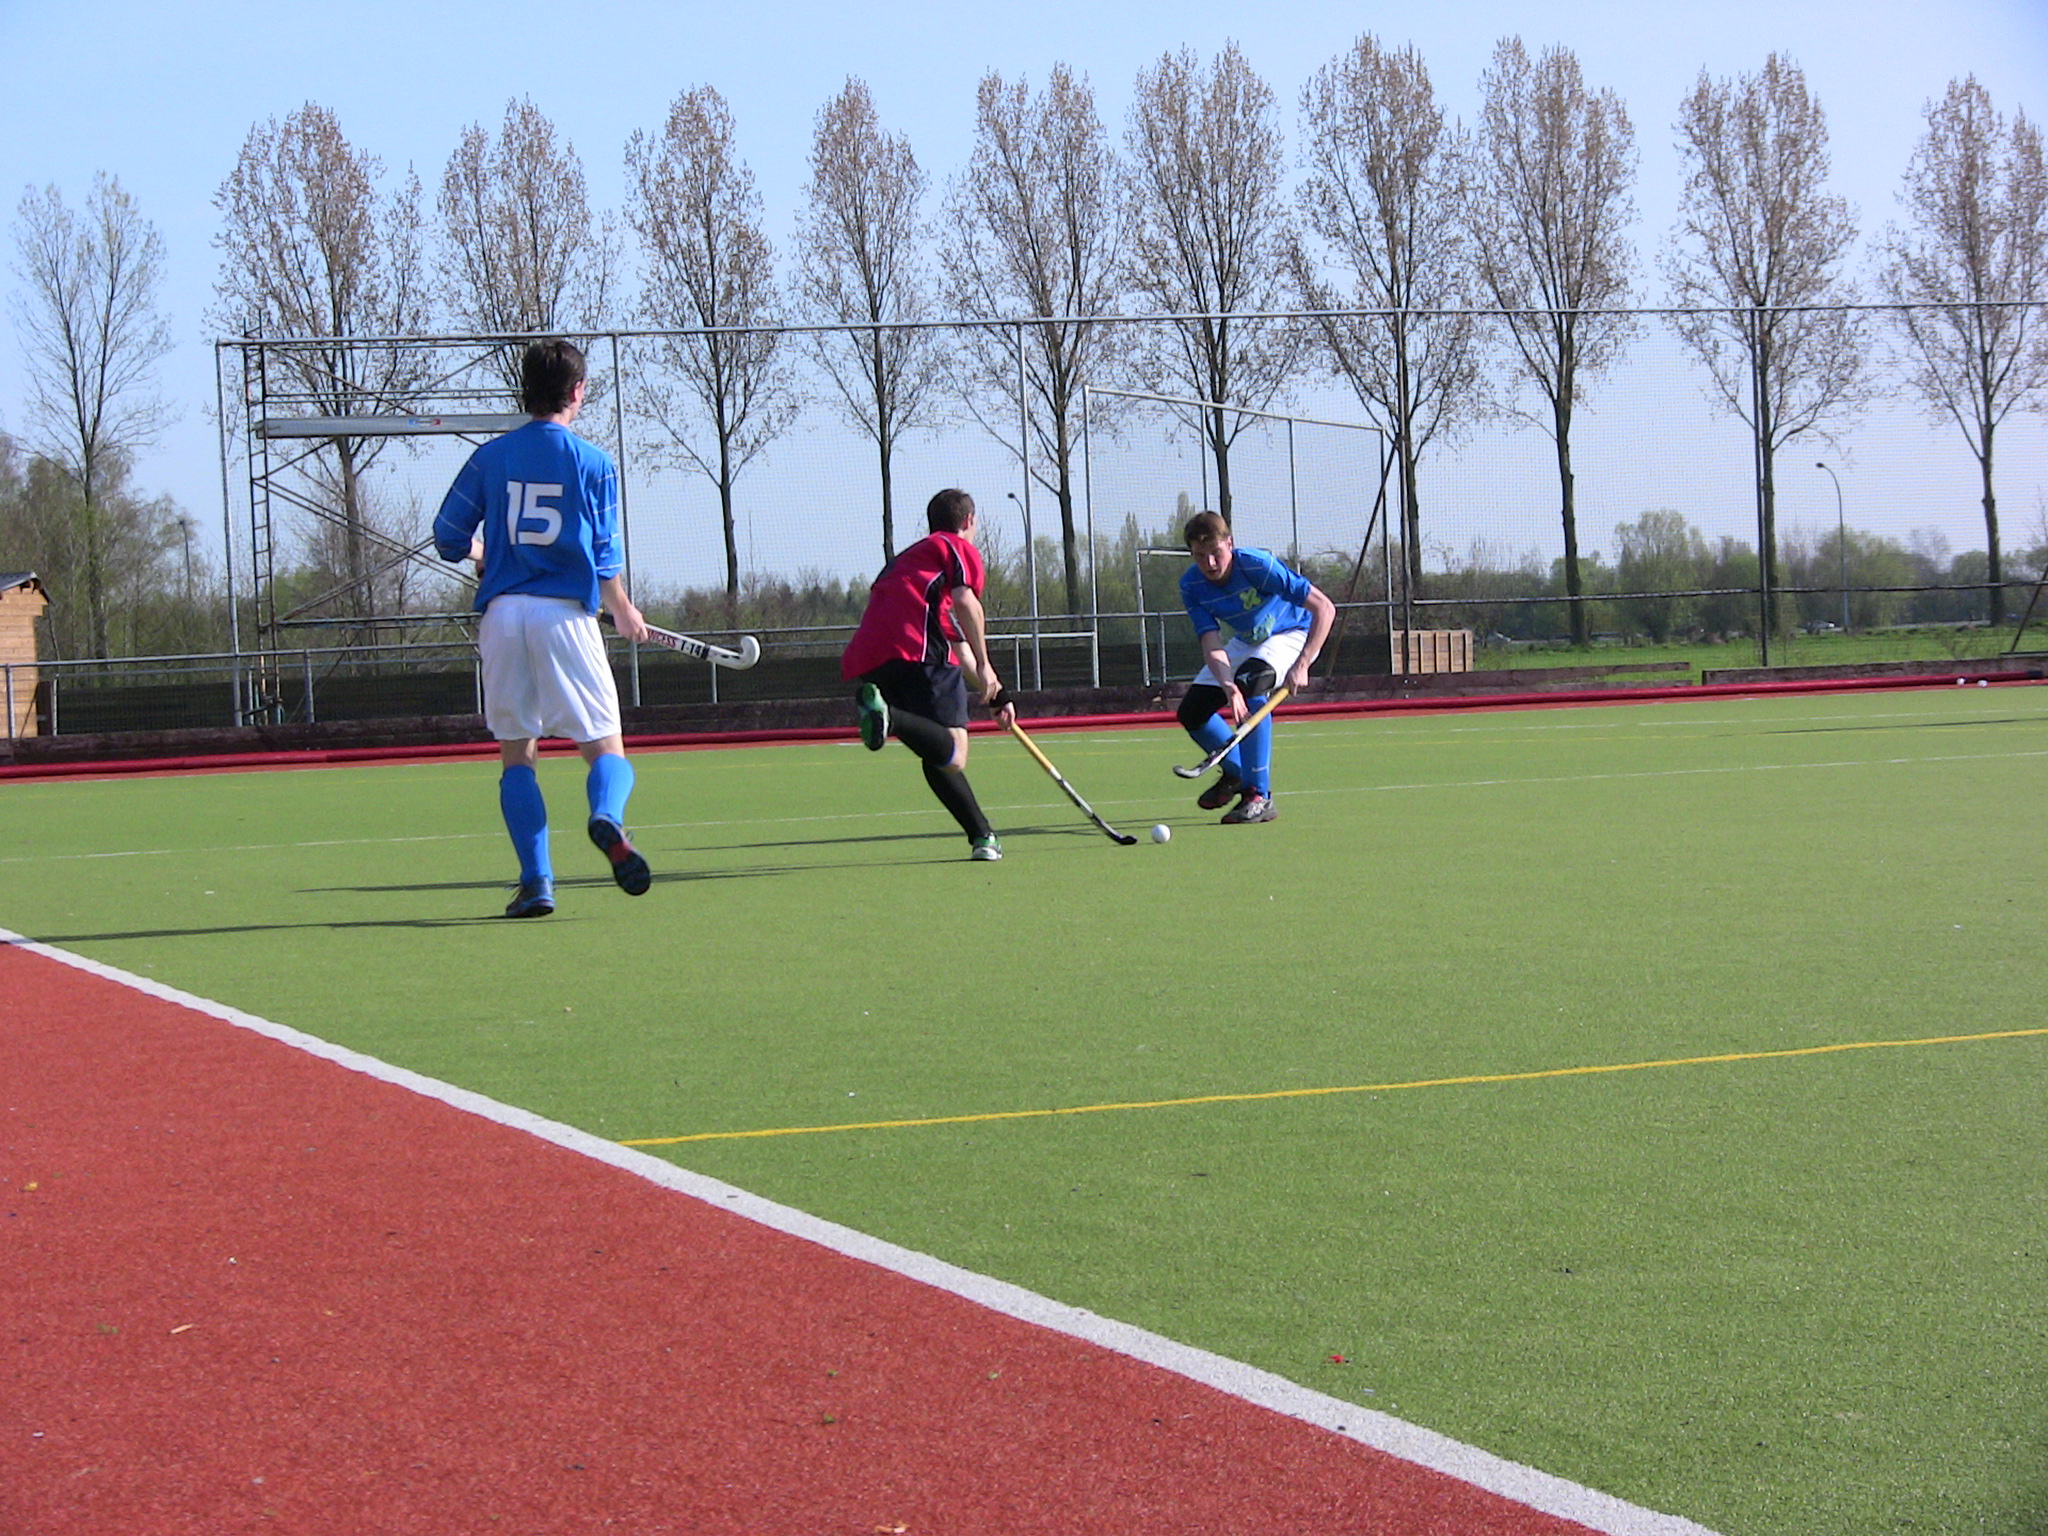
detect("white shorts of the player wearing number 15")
[477,592,618,743]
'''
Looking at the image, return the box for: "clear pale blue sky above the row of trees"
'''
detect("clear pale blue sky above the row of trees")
[0,0,2048,577]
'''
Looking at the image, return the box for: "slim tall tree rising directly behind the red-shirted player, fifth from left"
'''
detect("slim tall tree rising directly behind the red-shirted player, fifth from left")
[797,80,938,563]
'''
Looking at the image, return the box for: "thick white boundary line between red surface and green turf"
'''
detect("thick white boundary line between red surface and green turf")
[0,928,1716,1536]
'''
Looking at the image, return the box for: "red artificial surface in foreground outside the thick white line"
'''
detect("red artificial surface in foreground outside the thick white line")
[0,942,1698,1536]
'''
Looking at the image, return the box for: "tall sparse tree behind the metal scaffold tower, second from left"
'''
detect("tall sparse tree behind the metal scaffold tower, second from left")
[211,102,428,616]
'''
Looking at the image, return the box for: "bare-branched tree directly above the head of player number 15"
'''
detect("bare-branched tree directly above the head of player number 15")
[438,98,618,389]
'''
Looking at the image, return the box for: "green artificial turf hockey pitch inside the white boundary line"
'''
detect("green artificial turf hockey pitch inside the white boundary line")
[0,688,2048,1536]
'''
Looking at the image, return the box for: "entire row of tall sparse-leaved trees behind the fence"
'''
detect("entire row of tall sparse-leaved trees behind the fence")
[12,35,2048,663]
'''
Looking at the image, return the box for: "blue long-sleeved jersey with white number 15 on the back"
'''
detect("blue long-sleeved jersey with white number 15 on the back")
[434,422,625,614]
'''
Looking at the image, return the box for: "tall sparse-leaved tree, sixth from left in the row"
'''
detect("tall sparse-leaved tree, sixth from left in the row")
[942,63,1122,612]
